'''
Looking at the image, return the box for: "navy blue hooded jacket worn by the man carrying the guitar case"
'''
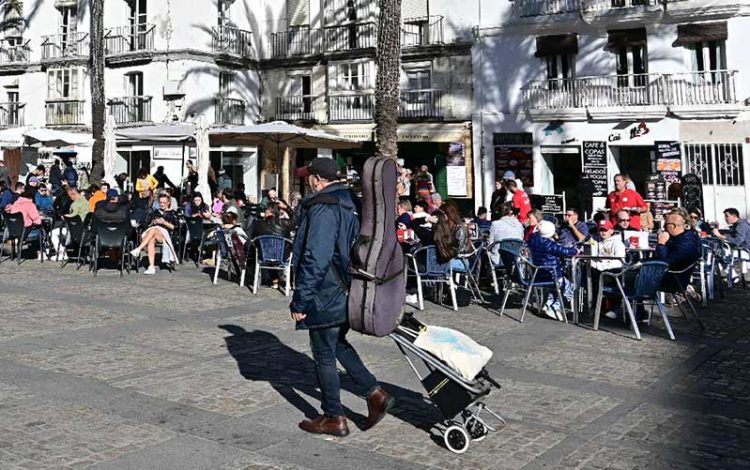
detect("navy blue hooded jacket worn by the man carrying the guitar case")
[289,184,359,329]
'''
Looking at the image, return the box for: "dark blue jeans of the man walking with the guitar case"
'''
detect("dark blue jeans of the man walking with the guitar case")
[310,326,378,416]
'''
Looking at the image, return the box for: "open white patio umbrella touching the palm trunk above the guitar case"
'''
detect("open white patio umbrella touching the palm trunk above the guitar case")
[211,121,360,187]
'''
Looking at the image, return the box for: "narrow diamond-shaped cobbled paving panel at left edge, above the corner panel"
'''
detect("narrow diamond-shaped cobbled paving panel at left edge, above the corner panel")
[2,340,190,380]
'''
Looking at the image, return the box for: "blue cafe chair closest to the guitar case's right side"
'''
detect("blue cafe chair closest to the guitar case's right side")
[406,245,458,311]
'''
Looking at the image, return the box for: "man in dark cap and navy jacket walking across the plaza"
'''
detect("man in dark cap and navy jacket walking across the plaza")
[289,158,395,437]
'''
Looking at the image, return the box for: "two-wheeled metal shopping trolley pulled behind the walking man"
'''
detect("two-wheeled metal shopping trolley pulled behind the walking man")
[389,313,506,454]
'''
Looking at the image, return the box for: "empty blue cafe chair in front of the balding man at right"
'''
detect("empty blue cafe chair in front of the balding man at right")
[594,261,674,340]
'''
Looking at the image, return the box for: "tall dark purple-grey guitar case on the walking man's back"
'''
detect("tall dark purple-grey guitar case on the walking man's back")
[348,157,406,336]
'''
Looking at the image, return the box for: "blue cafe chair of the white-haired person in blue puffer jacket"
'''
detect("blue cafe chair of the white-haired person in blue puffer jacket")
[500,249,568,323]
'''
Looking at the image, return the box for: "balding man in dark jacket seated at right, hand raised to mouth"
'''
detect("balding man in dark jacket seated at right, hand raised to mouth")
[655,212,702,292]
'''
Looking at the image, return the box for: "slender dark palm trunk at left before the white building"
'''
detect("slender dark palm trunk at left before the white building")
[89,0,106,184]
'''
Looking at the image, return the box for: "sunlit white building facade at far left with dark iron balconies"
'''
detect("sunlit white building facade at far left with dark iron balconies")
[0,0,260,194]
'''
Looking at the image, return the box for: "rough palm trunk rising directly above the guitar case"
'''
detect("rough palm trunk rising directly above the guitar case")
[375,0,401,159]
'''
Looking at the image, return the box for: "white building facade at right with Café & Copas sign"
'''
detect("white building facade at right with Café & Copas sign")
[473,0,750,220]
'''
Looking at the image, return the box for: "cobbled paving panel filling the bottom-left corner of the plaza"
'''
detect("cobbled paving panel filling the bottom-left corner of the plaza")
[0,402,174,469]
